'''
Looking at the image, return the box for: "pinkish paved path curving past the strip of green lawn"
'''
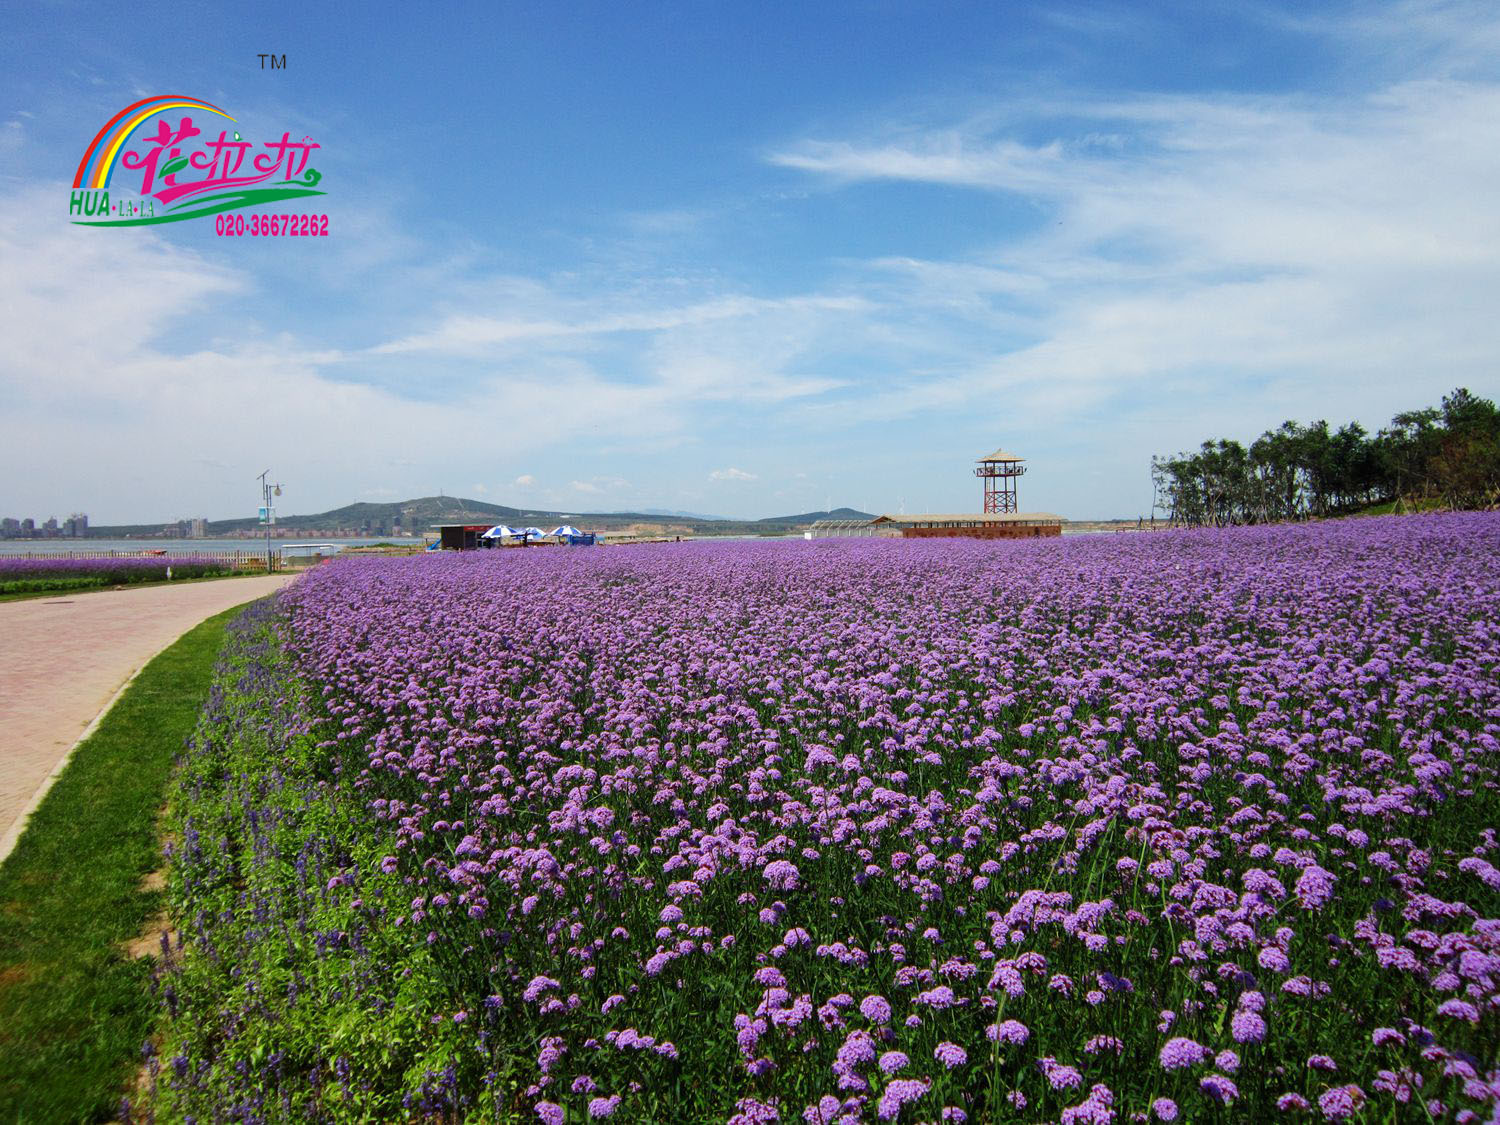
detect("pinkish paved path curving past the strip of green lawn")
[0,575,293,860]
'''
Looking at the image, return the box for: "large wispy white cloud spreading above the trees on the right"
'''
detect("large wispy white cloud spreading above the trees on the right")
[771,68,1500,435]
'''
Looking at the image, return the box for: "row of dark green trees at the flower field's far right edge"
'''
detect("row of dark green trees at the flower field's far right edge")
[1151,387,1500,527]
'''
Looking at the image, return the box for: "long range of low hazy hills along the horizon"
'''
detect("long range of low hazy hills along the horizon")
[89,497,870,539]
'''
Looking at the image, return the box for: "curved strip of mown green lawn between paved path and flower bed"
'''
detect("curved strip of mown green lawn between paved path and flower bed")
[0,608,243,1124]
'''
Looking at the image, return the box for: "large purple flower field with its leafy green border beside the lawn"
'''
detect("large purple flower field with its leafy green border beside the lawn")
[150,515,1500,1125]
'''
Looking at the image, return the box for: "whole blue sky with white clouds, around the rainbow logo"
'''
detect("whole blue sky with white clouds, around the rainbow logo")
[0,0,1500,524]
